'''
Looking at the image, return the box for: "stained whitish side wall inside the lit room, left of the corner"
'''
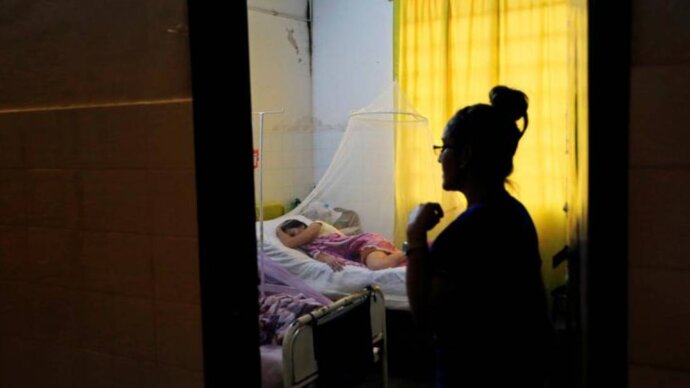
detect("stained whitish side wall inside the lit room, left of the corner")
[248,0,314,205]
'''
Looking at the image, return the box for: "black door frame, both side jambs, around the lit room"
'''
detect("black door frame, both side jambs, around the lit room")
[187,0,632,388]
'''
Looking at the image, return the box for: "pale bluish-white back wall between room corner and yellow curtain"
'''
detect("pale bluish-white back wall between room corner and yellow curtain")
[312,0,394,180]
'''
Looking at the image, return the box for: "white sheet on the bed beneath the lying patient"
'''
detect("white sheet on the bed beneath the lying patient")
[256,215,409,310]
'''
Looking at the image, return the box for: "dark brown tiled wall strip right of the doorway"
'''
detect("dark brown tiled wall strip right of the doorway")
[629,0,690,388]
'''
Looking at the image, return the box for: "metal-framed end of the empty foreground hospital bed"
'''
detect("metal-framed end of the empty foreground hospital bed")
[261,286,388,388]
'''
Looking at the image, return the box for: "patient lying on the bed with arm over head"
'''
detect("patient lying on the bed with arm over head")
[276,220,407,271]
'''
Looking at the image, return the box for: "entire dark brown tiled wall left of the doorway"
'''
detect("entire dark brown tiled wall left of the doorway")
[0,0,203,388]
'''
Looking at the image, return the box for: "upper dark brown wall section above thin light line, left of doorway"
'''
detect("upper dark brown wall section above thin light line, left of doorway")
[0,0,191,108]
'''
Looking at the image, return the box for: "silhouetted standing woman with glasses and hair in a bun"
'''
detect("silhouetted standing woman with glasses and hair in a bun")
[407,86,553,387]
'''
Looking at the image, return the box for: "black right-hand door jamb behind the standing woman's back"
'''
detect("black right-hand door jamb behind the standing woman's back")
[580,0,632,388]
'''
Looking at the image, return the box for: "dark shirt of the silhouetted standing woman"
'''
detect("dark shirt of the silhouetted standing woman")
[430,193,552,387]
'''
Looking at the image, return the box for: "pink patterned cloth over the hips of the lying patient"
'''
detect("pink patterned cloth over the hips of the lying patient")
[300,233,396,263]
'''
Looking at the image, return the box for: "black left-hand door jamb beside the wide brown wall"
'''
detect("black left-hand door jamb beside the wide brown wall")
[187,0,261,388]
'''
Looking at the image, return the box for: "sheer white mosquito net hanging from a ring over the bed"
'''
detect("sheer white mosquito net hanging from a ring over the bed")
[290,83,441,244]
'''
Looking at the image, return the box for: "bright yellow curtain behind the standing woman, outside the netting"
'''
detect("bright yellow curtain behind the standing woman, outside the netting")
[395,0,586,288]
